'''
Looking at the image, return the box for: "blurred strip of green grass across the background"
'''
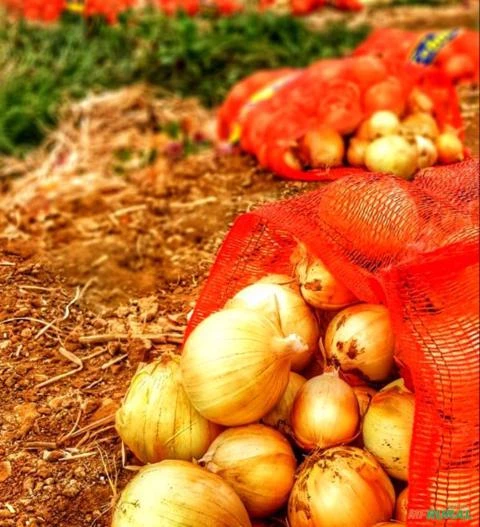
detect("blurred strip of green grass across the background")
[0,12,368,155]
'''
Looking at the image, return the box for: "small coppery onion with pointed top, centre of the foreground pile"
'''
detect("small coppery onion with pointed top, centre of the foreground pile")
[290,372,360,450]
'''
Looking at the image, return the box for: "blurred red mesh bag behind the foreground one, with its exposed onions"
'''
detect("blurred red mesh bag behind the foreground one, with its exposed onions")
[218,56,465,180]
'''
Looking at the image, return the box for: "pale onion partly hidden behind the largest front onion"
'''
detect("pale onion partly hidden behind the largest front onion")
[225,282,319,371]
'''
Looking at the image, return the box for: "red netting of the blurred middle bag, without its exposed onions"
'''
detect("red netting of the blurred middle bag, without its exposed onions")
[218,57,461,181]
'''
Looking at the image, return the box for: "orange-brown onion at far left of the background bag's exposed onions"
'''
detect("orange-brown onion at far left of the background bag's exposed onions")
[298,127,345,168]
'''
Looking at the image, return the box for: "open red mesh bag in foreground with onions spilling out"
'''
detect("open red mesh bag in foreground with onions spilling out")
[112,159,480,527]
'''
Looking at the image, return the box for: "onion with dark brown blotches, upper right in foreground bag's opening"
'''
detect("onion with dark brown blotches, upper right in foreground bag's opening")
[325,304,395,381]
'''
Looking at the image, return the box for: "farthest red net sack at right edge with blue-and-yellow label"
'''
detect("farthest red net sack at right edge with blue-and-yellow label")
[354,29,480,82]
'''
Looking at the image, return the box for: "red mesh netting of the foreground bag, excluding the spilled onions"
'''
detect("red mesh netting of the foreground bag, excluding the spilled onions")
[187,159,479,527]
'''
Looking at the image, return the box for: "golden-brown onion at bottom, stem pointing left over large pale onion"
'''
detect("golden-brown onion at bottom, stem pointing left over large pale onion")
[199,424,297,518]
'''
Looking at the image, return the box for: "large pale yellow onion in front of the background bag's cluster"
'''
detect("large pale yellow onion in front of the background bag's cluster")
[365,135,417,179]
